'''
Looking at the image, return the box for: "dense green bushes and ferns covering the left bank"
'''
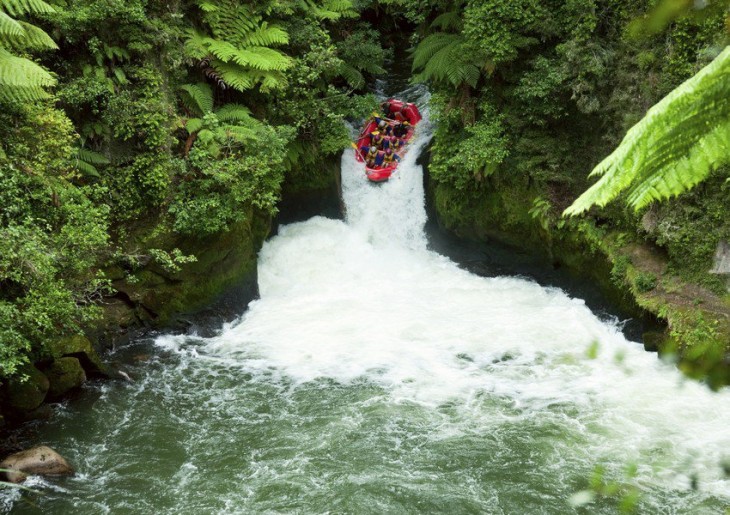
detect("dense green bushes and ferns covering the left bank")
[0,0,387,378]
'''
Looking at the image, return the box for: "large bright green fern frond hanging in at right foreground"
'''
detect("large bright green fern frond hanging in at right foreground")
[564,47,730,215]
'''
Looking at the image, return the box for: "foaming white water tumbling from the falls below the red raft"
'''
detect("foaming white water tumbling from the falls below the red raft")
[195,95,730,511]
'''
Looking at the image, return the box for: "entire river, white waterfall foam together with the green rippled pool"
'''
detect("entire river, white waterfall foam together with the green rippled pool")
[0,90,730,514]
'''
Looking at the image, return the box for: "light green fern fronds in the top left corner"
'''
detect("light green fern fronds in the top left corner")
[0,0,57,103]
